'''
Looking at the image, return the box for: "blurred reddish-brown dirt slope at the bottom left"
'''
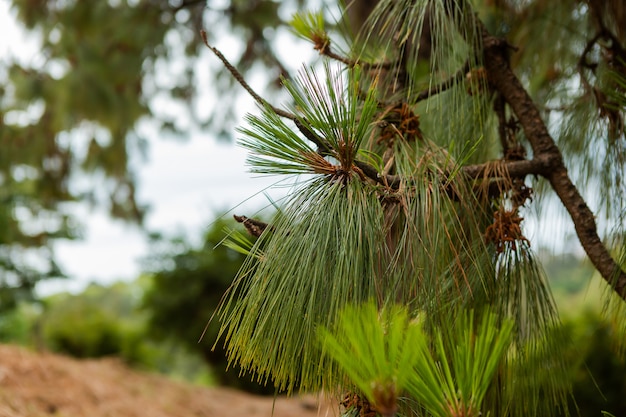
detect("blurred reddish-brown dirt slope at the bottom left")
[0,345,339,417]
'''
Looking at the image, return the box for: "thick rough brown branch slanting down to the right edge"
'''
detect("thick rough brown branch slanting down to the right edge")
[476,26,626,300]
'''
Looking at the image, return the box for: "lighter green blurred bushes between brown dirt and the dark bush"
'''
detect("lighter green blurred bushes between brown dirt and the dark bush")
[33,277,214,384]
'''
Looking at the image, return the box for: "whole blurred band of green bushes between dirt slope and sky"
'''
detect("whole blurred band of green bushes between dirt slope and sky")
[0,220,275,394]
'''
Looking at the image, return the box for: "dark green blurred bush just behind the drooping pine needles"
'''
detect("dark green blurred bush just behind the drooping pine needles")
[142,220,276,394]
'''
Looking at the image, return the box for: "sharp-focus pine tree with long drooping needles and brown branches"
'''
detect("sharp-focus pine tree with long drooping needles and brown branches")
[211,0,626,417]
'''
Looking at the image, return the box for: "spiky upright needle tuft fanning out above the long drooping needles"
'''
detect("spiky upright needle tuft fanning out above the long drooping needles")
[239,65,377,175]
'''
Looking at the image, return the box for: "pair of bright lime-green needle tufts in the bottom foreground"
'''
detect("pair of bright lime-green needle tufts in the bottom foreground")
[318,301,513,417]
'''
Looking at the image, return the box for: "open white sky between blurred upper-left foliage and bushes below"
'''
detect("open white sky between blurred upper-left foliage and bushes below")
[47,135,282,292]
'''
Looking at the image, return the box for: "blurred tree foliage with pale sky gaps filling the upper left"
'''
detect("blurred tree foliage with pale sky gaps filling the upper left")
[0,0,300,309]
